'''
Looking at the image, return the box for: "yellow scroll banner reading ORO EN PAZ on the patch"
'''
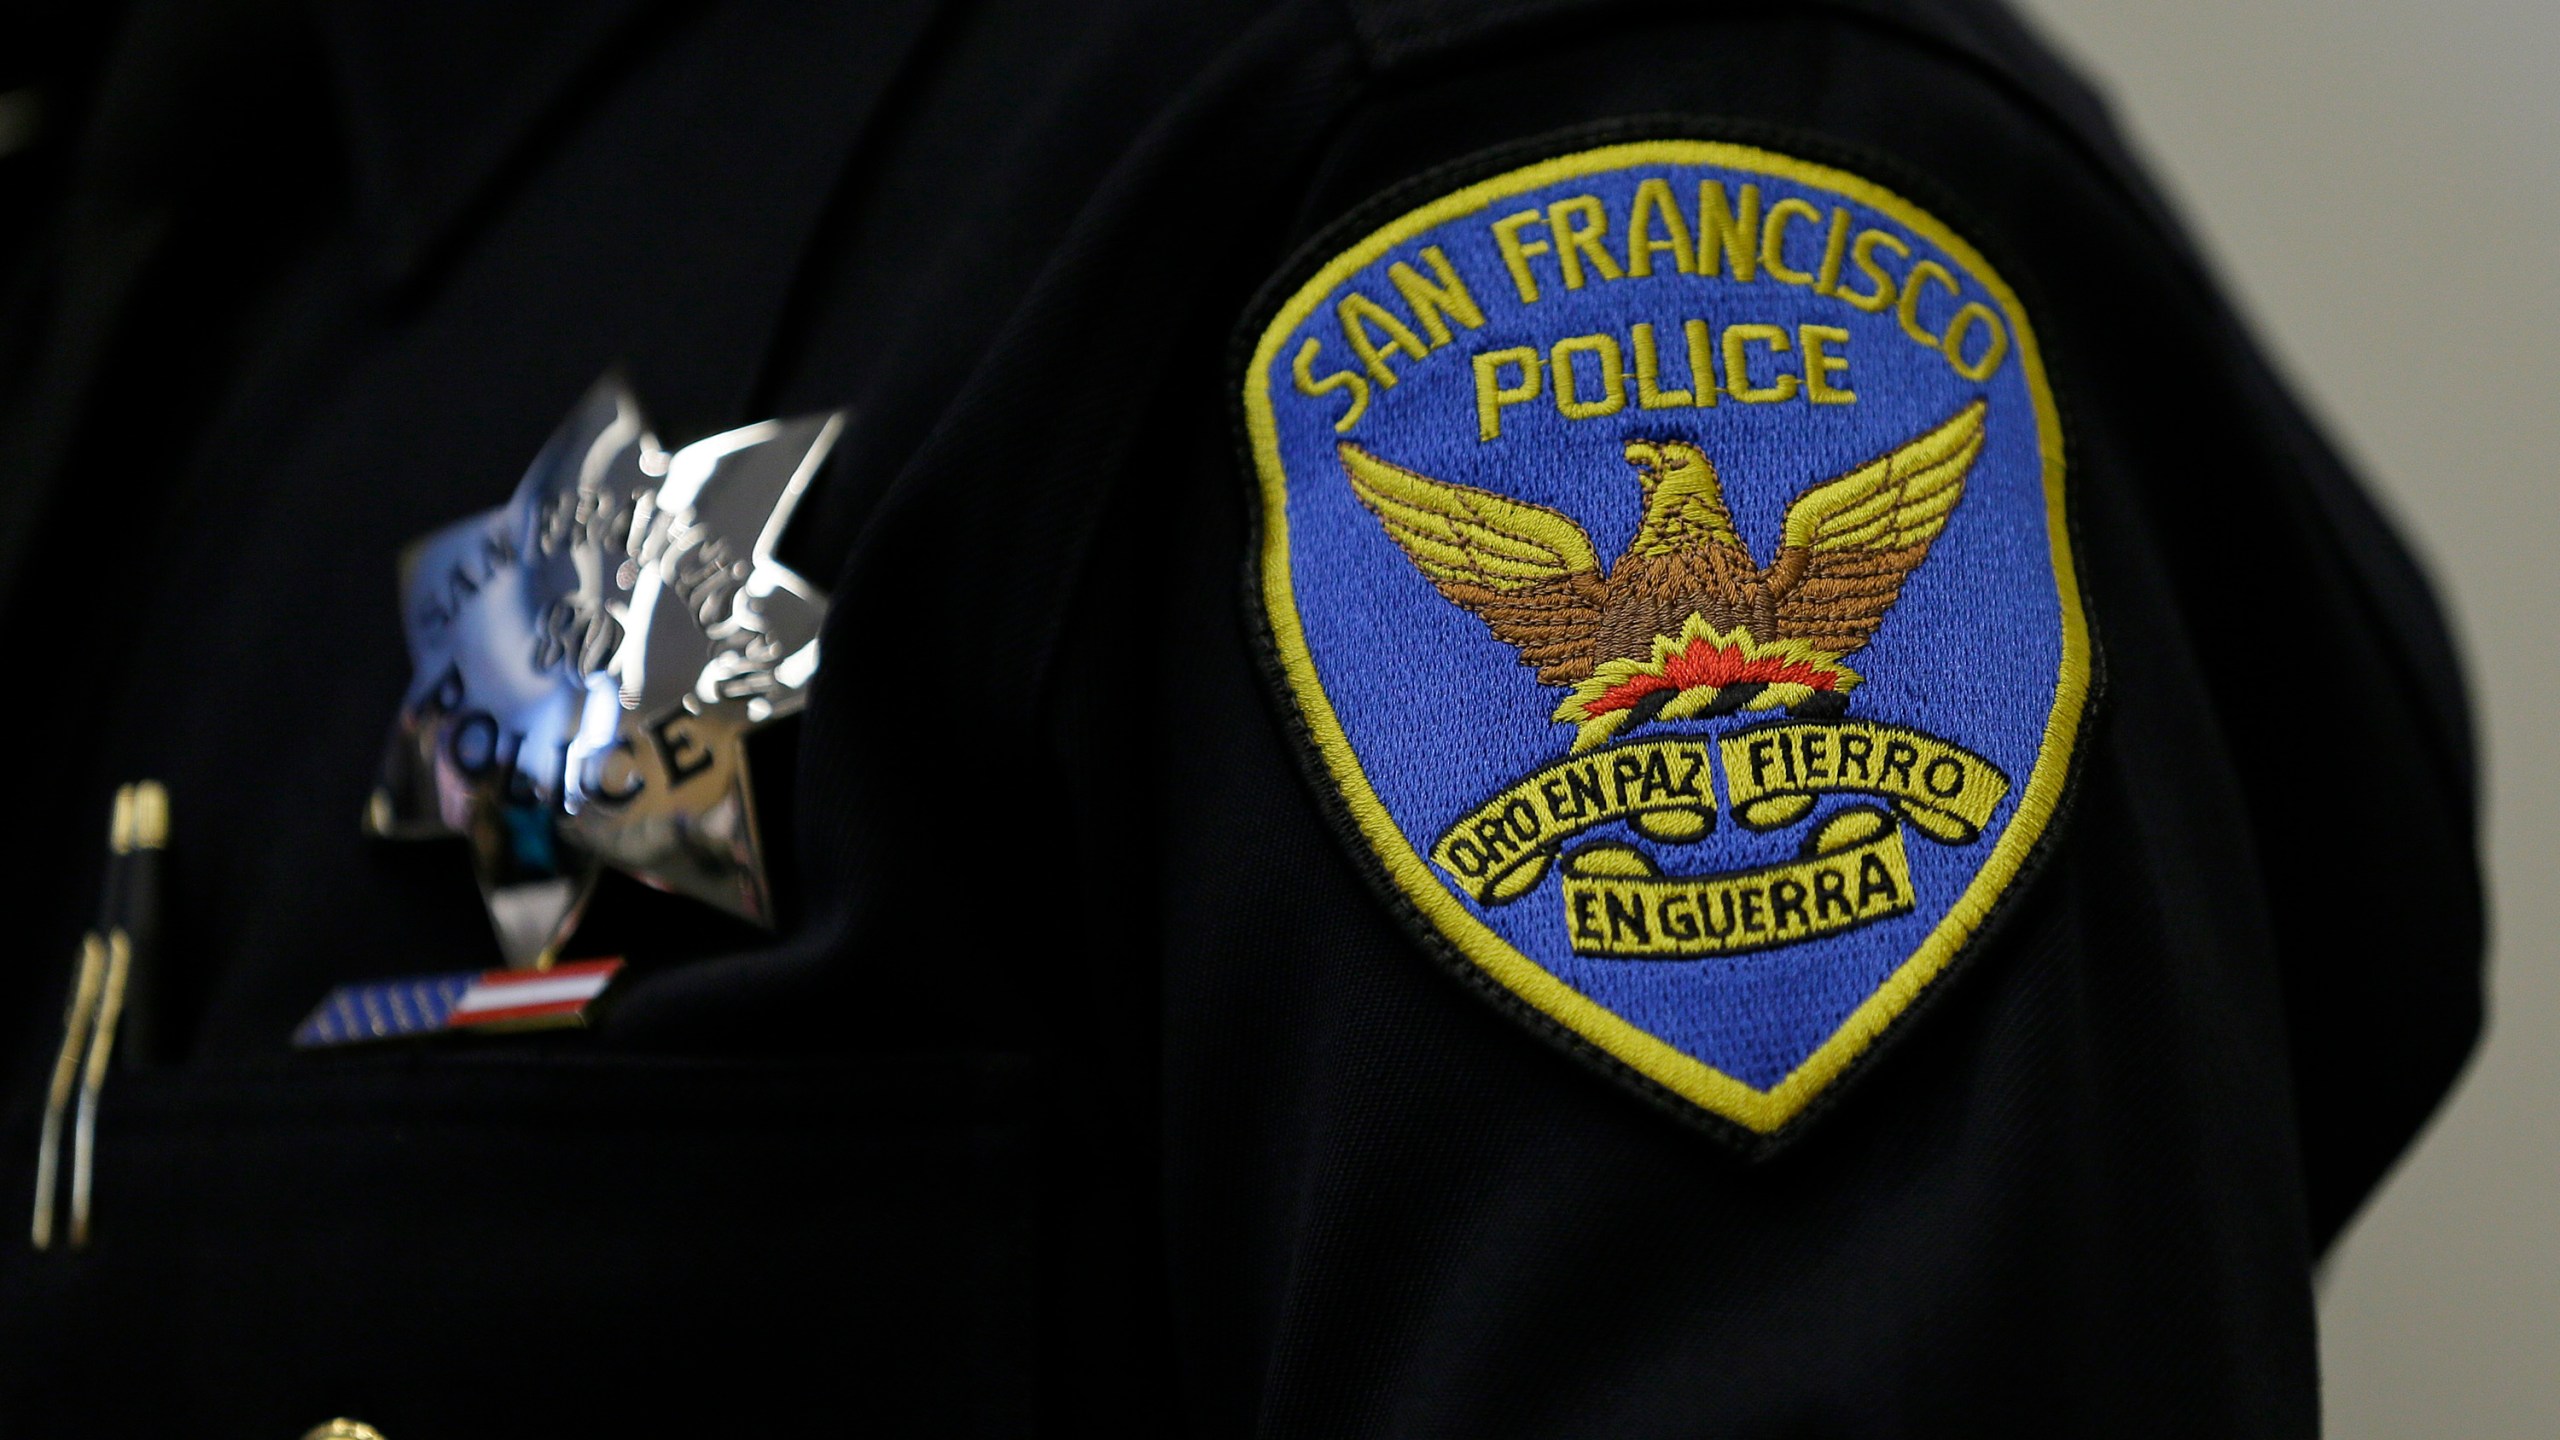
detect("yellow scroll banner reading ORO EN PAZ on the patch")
[1431,735,1715,904]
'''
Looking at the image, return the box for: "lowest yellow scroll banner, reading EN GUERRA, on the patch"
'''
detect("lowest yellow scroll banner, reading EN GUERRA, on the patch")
[1564,805,1912,961]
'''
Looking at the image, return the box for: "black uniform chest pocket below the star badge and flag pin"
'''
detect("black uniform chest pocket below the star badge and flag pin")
[0,1053,1034,1440]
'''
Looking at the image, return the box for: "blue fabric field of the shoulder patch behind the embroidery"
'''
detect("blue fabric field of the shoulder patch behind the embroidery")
[1270,164,2063,1089]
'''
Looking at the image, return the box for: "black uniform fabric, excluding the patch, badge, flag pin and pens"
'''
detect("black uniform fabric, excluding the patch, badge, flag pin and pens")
[0,0,2481,1440]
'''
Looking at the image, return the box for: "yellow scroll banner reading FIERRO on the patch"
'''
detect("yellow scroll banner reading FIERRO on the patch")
[1723,720,2010,846]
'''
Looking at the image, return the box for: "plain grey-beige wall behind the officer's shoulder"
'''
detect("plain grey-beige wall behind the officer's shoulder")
[2020,0,2560,1440]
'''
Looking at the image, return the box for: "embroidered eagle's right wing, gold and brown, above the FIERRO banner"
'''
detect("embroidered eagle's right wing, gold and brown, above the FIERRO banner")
[1769,400,1984,656]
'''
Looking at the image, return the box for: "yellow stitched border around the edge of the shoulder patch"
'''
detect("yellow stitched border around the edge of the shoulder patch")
[1244,138,2092,1135]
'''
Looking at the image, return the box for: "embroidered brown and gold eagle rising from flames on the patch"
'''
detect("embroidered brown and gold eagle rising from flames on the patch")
[1339,400,1984,751]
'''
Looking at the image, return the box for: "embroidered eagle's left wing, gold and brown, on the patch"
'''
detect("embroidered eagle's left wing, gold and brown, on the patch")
[1339,443,1603,684]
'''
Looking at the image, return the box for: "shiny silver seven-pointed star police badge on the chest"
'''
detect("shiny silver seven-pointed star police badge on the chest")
[366,377,845,969]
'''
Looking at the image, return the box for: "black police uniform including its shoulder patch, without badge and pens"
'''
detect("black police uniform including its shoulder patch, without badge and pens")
[0,0,2481,1440]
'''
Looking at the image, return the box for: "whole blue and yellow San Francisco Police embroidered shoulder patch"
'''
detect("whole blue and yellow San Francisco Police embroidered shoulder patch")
[1244,138,2089,1135]
